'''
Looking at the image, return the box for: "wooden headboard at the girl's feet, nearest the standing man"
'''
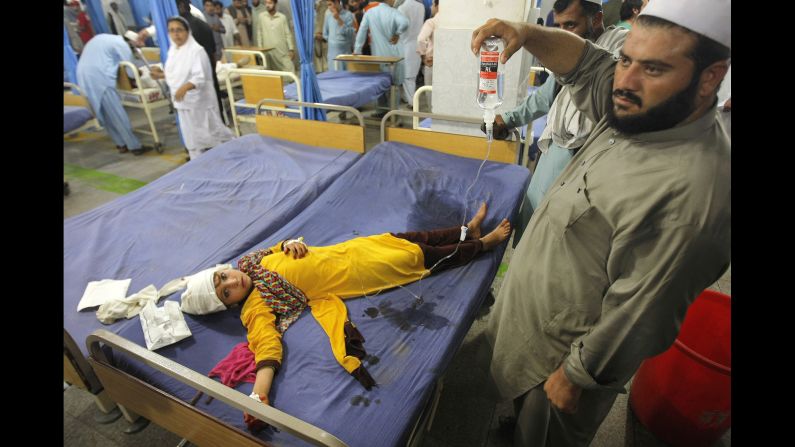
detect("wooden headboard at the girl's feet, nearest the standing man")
[381,110,521,163]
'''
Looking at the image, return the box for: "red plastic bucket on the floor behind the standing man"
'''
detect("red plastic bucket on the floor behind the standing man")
[629,290,731,446]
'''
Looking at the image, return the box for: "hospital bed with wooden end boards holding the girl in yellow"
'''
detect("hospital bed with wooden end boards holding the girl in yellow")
[86,112,529,446]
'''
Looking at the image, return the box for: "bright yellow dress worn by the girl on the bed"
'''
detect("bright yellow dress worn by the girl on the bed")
[240,233,429,373]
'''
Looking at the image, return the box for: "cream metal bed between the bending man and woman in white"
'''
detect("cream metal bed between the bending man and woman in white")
[116,57,170,153]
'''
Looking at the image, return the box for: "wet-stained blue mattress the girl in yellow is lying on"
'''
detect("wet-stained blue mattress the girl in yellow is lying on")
[105,143,530,447]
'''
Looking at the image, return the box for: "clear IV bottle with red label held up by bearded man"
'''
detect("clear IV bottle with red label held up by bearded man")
[477,37,505,139]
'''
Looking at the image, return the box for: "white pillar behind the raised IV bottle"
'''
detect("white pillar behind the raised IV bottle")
[431,0,539,135]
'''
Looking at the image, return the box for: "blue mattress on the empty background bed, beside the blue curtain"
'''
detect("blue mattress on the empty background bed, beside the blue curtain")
[236,71,392,116]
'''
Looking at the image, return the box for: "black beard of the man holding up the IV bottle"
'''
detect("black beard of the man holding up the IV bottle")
[607,74,700,135]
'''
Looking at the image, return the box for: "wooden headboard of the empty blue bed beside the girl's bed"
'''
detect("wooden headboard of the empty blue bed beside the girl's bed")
[256,99,365,154]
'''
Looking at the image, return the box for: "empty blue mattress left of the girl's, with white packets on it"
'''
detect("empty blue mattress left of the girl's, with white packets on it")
[64,135,359,355]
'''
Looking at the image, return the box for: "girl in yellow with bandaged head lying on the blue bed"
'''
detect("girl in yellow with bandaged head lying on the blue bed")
[181,203,511,431]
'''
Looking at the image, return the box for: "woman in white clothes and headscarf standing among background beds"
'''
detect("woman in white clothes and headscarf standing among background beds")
[152,17,234,160]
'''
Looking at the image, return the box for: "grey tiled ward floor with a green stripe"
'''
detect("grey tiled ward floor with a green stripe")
[64,102,731,447]
